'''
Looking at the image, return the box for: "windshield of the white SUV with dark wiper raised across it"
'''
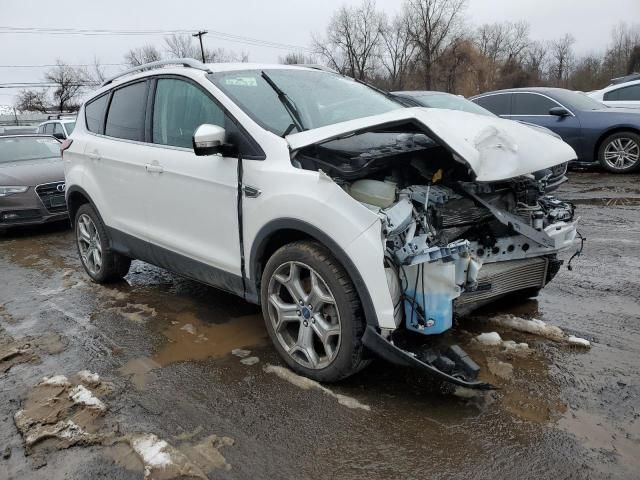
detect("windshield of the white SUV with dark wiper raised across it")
[209,69,403,135]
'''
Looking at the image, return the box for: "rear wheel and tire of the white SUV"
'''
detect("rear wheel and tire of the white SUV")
[74,203,131,283]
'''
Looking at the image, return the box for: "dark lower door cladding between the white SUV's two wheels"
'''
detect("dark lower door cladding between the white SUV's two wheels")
[107,227,250,300]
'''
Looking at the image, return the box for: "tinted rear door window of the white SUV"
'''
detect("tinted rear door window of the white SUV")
[104,82,147,142]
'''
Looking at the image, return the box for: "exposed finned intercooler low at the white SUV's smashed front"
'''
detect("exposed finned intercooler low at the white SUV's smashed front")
[454,257,549,313]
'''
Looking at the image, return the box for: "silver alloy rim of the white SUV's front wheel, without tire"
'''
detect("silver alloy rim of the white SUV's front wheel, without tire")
[268,261,341,370]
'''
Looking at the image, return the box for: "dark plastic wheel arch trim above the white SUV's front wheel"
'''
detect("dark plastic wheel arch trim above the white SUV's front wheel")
[247,218,378,327]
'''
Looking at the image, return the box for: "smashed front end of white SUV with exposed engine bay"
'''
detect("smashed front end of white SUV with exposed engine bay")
[293,108,577,388]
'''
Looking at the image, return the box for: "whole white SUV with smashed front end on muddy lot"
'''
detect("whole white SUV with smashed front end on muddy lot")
[63,60,576,388]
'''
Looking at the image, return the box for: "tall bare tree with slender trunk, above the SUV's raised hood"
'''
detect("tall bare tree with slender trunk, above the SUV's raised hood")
[405,0,466,90]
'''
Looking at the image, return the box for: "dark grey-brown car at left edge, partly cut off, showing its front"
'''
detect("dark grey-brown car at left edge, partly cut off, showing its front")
[0,135,68,231]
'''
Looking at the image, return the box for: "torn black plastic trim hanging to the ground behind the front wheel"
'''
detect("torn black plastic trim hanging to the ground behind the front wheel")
[362,325,496,390]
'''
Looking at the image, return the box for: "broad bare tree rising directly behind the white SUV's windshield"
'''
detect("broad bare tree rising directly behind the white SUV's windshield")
[313,0,383,80]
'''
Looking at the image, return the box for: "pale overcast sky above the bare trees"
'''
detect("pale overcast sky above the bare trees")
[0,0,640,104]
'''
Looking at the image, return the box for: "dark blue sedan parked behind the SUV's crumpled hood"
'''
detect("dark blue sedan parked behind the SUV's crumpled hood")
[471,87,640,173]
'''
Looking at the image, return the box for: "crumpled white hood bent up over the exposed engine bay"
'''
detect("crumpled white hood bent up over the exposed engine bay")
[286,107,577,182]
